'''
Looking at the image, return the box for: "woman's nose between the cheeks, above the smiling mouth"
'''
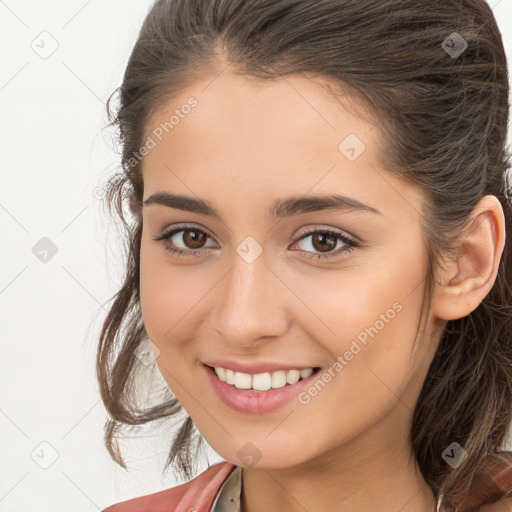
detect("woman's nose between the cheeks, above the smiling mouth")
[214,254,291,347]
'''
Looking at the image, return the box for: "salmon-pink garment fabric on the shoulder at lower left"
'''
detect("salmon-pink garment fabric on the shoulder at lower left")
[102,461,236,512]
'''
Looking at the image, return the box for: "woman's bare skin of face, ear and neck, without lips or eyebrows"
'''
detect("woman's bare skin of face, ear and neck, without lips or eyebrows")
[140,70,505,512]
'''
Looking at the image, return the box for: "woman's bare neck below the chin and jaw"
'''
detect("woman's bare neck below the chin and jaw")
[240,406,437,512]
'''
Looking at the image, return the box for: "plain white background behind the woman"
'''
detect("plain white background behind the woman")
[0,0,512,512]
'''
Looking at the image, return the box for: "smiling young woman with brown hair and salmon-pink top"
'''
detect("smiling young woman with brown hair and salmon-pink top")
[97,0,512,512]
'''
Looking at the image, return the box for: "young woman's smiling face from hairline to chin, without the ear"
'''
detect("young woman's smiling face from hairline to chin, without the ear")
[140,71,436,468]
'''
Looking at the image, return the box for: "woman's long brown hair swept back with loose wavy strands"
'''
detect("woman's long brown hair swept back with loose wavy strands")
[97,0,512,511]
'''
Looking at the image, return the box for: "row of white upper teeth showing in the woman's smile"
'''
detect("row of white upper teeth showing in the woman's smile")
[215,366,313,391]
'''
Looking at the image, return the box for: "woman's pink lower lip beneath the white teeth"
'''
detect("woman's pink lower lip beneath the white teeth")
[203,365,319,414]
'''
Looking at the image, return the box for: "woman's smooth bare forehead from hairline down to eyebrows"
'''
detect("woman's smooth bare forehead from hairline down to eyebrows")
[143,72,424,223]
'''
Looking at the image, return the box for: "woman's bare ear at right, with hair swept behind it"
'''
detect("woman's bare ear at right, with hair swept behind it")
[432,195,505,321]
